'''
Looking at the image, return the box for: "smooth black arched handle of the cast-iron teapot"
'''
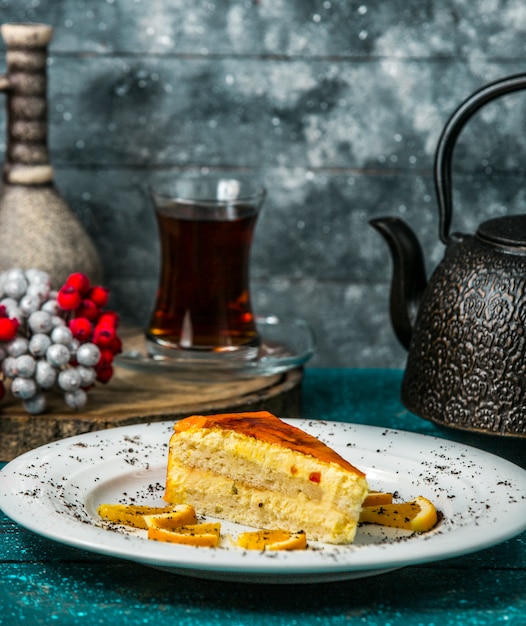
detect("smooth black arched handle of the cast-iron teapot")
[434,74,526,244]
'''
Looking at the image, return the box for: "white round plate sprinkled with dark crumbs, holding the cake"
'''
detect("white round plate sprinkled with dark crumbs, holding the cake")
[0,420,526,583]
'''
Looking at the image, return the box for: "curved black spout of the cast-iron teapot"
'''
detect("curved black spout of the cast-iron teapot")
[369,217,427,349]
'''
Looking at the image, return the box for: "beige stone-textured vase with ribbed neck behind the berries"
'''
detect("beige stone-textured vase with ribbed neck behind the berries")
[0,24,102,285]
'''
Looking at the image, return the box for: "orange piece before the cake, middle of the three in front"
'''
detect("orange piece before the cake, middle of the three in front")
[144,513,221,548]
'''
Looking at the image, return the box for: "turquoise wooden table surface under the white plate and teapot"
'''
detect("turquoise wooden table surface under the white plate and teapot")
[0,369,526,626]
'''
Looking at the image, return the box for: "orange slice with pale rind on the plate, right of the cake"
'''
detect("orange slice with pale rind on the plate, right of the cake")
[360,496,438,533]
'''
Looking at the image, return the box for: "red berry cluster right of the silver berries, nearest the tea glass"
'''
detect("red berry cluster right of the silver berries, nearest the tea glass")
[57,272,122,383]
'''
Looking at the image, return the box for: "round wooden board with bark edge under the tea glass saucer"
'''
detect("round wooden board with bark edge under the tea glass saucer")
[0,367,303,461]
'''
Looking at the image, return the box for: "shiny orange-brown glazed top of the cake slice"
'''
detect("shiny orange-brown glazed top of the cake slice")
[174,411,365,476]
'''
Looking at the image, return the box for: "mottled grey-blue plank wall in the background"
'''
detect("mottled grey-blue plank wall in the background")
[0,0,526,367]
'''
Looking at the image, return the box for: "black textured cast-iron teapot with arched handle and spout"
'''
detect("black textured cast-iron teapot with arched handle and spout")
[371,74,526,437]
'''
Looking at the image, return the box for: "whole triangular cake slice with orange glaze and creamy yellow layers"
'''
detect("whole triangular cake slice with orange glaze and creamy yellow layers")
[164,411,368,543]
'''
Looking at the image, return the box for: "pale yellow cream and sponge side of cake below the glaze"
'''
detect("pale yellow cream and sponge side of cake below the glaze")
[165,430,367,543]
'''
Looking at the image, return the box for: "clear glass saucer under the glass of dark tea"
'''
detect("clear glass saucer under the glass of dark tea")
[115,315,315,383]
